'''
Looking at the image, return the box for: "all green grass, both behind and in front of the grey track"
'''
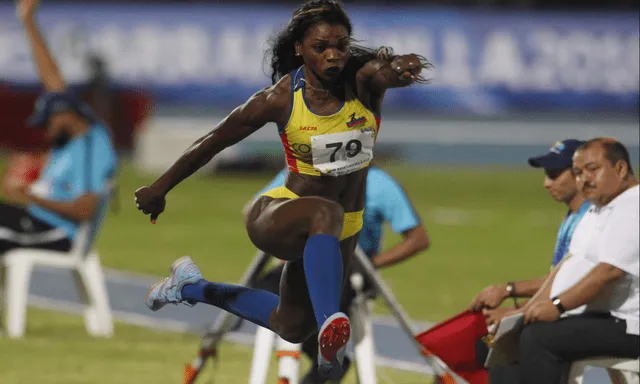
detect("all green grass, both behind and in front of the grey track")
[0,158,564,384]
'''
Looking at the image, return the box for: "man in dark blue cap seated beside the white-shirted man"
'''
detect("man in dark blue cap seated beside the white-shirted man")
[471,139,590,326]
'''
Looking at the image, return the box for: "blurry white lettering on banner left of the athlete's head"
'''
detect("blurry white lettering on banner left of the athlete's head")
[90,25,266,84]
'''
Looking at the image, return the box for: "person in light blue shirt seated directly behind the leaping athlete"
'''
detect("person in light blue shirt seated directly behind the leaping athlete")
[245,166,430,384]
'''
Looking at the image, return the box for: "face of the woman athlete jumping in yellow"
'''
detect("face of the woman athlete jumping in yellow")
[296,22,350,81]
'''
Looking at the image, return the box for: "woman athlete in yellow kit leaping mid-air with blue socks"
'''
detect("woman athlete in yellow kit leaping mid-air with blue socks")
[135,0,430,378]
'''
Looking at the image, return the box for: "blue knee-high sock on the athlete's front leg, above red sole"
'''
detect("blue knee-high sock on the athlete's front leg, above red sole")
[303,234,342,328]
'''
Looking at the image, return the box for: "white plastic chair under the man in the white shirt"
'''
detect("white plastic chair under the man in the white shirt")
[567,357,640,384]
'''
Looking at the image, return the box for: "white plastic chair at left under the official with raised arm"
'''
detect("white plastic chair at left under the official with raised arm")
[0,201,113,338]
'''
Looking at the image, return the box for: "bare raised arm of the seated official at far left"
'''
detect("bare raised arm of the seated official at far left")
[17,0,65,91]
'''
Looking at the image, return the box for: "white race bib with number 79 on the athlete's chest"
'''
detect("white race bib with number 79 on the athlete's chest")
[311,129,375,176]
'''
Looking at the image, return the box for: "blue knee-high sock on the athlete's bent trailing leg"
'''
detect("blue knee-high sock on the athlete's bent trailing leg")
[182,280,280,329]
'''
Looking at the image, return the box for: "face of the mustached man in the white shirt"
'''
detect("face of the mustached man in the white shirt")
[573,144,629,206]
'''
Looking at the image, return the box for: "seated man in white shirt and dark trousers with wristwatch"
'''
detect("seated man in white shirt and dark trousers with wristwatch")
[498,138,640,384]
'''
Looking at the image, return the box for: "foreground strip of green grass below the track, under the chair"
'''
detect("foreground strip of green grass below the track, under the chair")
[0,309,431,384]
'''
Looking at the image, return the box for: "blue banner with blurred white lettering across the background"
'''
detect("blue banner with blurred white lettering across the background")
[0,4,640,115]
